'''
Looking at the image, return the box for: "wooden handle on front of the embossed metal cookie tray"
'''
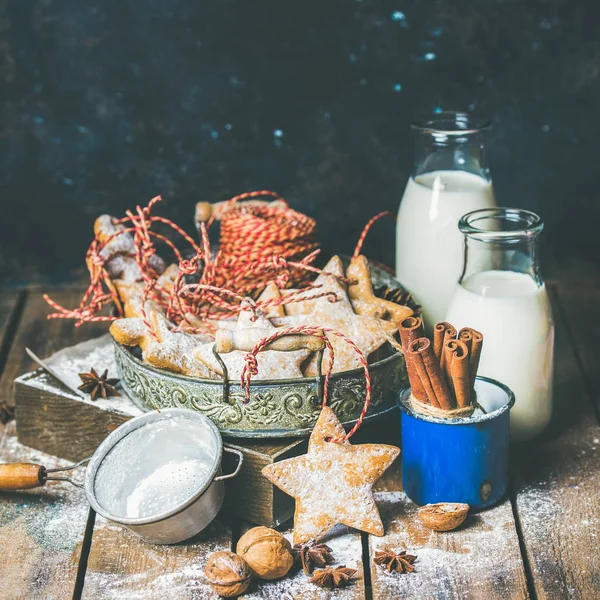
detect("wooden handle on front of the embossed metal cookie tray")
[215,327,325,354]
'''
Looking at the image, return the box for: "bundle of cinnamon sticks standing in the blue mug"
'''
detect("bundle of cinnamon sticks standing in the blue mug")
[400,317,483,416]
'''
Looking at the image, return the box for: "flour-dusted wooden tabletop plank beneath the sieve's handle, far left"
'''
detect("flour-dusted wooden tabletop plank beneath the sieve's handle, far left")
[0,421,89,600]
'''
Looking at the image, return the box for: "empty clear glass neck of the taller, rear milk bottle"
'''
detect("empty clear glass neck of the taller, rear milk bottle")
[412,112,490,181]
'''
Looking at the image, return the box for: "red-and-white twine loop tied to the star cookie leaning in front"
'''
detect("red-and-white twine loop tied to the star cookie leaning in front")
[240,325,371,442]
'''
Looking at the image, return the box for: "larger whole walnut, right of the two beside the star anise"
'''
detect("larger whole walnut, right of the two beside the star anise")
[236,527,294,579]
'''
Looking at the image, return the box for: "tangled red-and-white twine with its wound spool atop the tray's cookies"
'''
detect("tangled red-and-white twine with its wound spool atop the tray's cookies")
[44,190,385,335]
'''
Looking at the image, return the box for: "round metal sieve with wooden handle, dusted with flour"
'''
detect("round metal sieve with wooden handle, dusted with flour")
[0,408,243,544]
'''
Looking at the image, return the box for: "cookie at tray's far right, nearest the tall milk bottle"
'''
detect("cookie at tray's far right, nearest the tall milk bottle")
[346,254,413,324]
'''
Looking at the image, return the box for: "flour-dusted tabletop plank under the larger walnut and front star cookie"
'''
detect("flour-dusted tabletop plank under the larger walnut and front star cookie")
[240,524,366,600]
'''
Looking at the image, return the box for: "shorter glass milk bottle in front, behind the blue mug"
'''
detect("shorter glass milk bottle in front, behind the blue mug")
[446,208,554,440]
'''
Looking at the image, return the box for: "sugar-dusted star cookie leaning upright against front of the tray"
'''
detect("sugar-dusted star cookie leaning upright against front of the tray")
[262,407,400,544]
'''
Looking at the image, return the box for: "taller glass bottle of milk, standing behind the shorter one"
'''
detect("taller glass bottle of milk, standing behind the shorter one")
[396,112,496,332]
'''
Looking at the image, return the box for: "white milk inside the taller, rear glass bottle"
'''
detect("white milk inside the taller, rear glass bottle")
[396,171,496,329]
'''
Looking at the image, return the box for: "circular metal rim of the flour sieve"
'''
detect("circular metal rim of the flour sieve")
[85,408,223,525]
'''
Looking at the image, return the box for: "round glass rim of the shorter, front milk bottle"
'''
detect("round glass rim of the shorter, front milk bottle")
[458,207,544,242]
